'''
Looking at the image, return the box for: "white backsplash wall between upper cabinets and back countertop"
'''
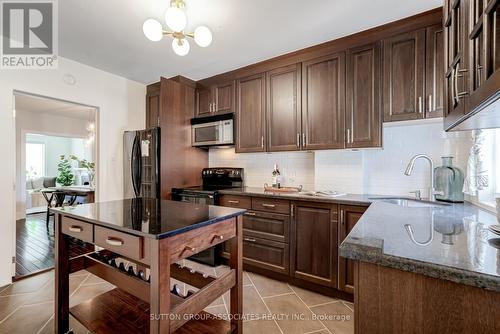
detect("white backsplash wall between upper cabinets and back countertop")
[209,119,470,195]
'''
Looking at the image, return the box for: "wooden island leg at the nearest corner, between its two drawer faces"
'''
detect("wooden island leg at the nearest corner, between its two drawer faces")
[149,239,170,334]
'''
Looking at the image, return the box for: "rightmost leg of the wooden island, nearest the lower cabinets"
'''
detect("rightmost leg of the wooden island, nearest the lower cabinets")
[229,216,243,334]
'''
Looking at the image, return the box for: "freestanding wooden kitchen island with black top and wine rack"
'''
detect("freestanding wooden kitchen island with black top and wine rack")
[51,198,245,333]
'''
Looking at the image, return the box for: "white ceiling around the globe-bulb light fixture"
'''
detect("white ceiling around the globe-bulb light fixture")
[59,0,442,83]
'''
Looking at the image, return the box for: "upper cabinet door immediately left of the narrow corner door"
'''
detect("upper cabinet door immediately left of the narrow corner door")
[383,30,425,122]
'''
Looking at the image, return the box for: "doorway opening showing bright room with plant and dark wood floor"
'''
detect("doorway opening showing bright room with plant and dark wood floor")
[14,92,98,280]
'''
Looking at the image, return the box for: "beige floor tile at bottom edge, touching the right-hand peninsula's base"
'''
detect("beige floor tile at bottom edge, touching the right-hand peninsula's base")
[311,301,354,334]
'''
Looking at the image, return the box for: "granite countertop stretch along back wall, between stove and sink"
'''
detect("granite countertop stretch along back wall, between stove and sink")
[219,187,380,206]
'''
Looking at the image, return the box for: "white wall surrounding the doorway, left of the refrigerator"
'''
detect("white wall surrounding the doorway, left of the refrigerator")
[0,57,146,286]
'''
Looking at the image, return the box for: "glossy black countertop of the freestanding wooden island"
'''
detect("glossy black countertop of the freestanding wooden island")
[51,198,246,239]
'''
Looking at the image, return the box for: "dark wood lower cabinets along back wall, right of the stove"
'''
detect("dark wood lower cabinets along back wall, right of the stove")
[220,195,367,299]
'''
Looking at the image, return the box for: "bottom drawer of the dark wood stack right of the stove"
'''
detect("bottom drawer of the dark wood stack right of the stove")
[243,236,290,274]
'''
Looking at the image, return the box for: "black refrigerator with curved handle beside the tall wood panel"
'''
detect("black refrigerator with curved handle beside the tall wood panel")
[123,128,160,198]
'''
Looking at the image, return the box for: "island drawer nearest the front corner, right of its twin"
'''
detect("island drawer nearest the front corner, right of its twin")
[94,226,149,264]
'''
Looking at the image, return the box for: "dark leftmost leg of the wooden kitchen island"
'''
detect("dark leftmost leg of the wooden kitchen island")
[54,214,69,334]
